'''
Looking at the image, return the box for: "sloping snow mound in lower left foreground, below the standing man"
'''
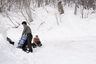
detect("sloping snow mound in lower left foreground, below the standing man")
[0,26,33,64]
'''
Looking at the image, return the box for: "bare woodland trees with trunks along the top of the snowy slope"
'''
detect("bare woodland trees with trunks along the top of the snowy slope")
[0,0,96,27]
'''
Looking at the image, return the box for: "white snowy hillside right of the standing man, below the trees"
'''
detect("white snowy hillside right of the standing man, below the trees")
[30,7,96,40]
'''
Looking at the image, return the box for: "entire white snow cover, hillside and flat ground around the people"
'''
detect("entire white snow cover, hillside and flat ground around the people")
[0,7,96,64]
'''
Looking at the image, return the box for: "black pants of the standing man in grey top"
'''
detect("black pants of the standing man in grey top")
[22,33,33,52]
